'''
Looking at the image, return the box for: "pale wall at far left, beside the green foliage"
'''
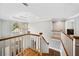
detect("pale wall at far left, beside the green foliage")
[0,20,13,36]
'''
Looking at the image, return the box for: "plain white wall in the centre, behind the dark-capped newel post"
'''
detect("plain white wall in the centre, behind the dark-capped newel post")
[29,21,52,40]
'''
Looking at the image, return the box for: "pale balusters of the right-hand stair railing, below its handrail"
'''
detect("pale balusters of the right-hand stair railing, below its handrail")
[61,33,73,56]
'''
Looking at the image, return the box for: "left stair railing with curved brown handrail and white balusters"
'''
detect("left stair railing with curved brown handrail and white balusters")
[0,33,48,56]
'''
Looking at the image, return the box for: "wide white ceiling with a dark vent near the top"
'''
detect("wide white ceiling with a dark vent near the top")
[0,3,79,22]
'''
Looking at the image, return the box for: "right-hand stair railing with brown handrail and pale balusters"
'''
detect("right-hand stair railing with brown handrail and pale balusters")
[61,32,74,56]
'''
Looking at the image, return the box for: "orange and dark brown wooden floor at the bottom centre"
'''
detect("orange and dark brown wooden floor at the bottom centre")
[17,48,60,56]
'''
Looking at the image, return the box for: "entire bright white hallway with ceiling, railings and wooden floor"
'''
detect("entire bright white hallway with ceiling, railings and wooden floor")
[0,3,79,56]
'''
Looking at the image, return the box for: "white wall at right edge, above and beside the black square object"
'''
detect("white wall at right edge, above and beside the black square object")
[65,16,79,35]
